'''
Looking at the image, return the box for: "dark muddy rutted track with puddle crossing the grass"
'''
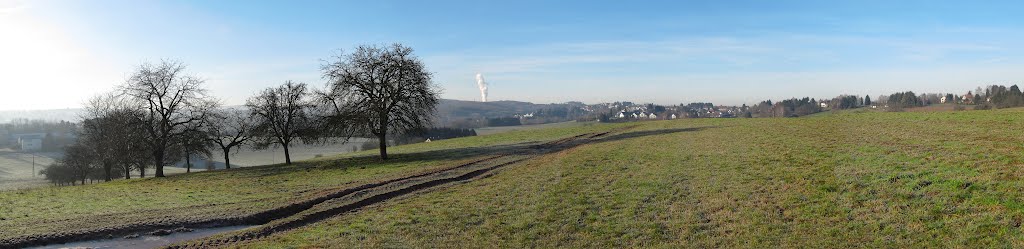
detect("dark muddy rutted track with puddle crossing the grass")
[0,127,631,248]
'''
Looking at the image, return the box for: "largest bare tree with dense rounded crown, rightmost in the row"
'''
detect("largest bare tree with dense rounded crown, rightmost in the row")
[318,44,439,160]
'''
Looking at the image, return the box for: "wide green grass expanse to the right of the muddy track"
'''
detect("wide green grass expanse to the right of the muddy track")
[234,110,1024,248]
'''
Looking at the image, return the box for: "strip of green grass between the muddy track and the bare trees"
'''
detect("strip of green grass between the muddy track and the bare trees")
[0,120,613,239]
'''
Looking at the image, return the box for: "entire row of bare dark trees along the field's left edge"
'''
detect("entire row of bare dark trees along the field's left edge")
[45,44,439,184]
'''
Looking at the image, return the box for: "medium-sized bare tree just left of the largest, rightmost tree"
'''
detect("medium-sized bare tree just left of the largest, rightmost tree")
[246,81,311,164]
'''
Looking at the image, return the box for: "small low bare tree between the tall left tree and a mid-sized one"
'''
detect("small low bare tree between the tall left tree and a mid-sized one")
[205,110,255,169]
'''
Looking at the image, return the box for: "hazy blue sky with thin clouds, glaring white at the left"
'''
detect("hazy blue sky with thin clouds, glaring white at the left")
[0,0,1024,110]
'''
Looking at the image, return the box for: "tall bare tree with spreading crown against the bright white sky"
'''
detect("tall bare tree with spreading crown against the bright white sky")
[122,60,216,177]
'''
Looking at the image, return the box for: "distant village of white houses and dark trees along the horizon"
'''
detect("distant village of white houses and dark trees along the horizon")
[493,85,1024,126]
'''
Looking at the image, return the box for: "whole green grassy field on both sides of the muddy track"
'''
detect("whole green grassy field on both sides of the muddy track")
[6,109,1024,248]
